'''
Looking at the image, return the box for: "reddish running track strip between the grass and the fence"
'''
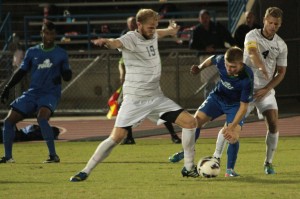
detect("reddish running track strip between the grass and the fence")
[18,113,300,141]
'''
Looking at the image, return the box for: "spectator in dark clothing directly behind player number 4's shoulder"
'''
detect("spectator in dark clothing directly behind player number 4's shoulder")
[234,11,261,48]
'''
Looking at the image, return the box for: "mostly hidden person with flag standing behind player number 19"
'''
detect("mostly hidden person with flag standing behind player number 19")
[118,16,181,144]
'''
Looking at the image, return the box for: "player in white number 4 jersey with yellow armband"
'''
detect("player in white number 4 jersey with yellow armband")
[214,7,288,174]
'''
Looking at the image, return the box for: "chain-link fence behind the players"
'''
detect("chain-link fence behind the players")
[0,49,209,115]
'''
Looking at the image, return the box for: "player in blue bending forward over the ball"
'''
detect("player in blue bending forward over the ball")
[170,47,253,176]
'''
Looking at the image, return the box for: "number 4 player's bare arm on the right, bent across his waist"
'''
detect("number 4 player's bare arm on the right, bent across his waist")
[254,66,286,100]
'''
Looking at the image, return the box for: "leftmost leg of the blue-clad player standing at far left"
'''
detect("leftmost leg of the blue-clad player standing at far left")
[0,109,23,163]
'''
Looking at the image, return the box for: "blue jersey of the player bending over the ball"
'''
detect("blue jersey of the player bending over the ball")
[212,55,253,104]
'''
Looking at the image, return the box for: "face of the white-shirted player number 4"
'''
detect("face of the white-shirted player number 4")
[263,16,282,39]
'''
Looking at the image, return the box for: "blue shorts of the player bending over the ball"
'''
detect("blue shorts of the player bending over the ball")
[198,93,245,126]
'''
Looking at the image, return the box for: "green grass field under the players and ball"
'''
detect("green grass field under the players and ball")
[0,137,300,199]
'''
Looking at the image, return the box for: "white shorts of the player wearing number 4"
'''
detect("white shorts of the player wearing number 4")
[246,89,278,119]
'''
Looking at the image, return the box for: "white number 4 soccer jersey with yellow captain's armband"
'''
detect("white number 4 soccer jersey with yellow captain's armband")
[244,29,288,90]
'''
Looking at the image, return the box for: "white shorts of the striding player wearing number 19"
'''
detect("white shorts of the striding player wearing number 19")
[115,96,182,127]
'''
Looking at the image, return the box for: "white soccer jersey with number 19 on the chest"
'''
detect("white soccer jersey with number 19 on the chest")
[119,31,162,100]
